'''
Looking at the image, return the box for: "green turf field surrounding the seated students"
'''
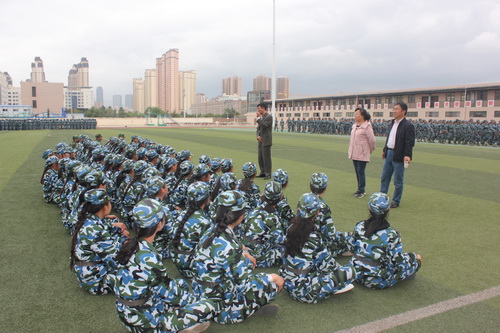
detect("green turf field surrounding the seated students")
[0,128,500,332]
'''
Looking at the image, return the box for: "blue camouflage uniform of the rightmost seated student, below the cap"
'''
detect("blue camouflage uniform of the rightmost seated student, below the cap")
[348,221,420,289]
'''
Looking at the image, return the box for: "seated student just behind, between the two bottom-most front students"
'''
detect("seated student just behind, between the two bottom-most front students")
[170,182,212,278]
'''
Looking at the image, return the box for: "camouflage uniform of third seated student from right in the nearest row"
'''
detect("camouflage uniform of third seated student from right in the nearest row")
[193,228,278,324]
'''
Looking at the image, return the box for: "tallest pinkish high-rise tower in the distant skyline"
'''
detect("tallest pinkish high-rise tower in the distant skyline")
[156,49,179,113]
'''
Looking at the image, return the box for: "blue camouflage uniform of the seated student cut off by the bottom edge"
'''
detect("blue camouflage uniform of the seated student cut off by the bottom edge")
[114,240,215,332]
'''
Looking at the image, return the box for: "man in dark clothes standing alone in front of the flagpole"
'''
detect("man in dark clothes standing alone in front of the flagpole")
[257,103,273,179]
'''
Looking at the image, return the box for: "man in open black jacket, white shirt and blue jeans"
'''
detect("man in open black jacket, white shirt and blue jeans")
[380,103,415,208]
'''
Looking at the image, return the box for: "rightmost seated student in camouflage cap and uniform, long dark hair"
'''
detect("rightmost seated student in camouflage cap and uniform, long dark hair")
[348,192,422,289]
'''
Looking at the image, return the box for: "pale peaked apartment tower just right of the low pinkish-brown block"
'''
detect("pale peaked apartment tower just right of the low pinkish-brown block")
[64,57,94,110]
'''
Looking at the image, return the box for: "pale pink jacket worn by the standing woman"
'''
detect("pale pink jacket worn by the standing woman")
[349,121,375,162]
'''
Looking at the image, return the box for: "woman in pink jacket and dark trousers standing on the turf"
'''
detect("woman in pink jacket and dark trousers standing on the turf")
[349,108,375,198]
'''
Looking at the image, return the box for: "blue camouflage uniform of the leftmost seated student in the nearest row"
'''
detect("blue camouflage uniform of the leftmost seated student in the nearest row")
[74,215,124,295]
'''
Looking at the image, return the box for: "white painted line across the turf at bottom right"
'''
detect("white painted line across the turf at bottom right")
[337,286,500,333]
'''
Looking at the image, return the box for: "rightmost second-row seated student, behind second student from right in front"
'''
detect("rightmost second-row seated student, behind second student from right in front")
[309,172,351,257]
